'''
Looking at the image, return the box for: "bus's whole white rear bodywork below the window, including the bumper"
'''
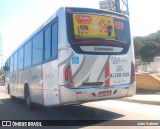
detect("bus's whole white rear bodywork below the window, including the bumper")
[59,6,135,103]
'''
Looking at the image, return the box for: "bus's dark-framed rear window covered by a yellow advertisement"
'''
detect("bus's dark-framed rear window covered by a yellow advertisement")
[67,13,130,55]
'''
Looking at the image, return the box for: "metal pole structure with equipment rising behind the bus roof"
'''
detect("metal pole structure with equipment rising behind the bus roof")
[99,0,129,16]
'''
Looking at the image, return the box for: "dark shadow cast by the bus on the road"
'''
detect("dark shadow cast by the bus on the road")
[0,98,124,127]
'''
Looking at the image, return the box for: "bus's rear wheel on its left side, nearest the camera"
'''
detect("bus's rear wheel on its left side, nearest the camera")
[25,86,32,110]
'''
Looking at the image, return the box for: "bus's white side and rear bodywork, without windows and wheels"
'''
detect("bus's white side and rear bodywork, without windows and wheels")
[6,8,136,106]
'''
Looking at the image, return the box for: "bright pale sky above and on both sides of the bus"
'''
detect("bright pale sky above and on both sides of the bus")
[0,0,160,61]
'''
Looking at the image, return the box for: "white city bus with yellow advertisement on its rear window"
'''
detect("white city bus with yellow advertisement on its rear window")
[5,7,136,109]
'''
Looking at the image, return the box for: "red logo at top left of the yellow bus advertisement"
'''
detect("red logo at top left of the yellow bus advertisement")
[76,15,92,24]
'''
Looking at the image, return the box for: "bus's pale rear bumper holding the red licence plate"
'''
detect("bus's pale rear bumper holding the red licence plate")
[60,83,136,104]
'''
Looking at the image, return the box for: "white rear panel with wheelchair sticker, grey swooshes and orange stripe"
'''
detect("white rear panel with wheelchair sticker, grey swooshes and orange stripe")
[70,55,131,87]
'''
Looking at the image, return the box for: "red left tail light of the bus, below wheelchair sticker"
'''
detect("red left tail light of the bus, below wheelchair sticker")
[64,65,73,88]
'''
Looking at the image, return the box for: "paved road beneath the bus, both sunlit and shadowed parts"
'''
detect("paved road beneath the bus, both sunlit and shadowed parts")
[0,86,160,129]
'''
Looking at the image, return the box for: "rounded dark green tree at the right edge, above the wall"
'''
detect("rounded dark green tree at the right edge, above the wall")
[140,41,160,62]
